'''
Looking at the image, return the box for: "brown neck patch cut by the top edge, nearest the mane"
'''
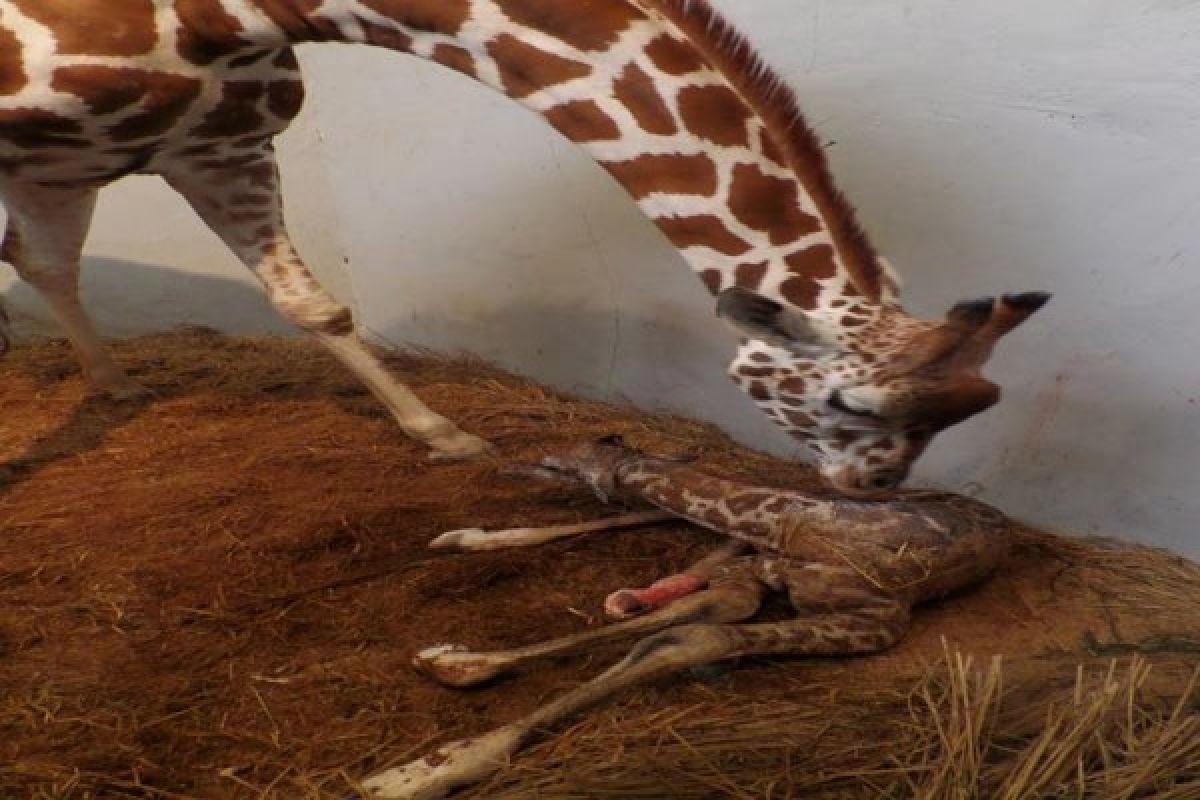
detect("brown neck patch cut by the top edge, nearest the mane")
[497,0,644,50]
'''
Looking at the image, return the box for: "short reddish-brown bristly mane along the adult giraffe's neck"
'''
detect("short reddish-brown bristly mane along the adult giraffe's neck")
[643,0,883,301]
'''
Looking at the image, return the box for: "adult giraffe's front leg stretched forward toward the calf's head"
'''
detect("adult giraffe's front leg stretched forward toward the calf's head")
[164,152,488,458]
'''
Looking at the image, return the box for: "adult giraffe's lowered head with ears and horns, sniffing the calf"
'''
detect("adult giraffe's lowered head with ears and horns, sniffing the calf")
[718,289,1050,489]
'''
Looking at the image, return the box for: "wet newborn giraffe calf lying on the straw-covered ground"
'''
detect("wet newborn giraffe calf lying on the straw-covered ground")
[365,439,1010,800]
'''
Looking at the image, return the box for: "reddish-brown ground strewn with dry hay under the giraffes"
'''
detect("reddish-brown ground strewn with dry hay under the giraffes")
[0,331,1200,800]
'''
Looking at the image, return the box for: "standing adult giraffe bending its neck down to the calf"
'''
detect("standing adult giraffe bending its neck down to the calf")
[0,0,1048,488]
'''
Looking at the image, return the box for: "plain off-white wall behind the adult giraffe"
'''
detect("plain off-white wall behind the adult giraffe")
[2,0,1200,555]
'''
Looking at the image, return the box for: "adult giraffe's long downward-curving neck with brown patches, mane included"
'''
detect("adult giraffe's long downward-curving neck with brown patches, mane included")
[204,0,882,335]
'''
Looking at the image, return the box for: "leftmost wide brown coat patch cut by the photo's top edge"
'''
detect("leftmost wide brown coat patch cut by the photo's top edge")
[14,0,158,56]
